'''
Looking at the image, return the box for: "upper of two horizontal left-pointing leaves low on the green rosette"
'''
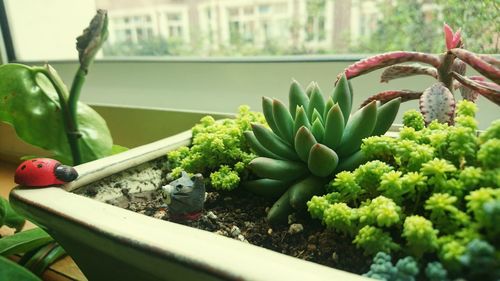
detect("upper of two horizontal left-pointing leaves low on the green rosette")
[248,157,309,181]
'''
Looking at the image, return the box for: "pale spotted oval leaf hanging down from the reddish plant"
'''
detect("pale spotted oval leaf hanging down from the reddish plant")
[420,83,455,124]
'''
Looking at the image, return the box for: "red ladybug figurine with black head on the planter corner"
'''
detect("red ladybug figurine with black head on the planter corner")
[14,158,78,187]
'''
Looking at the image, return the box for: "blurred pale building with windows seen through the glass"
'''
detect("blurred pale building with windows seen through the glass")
[96,0,377,54]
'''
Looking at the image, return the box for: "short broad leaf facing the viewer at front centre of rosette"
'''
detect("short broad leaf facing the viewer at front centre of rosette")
[307,143,339,177]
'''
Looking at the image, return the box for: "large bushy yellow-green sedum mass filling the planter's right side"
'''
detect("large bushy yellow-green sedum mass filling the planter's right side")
[307,101,500,280]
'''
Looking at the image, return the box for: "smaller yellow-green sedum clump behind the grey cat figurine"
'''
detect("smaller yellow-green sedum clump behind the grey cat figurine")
[167,106,266,190]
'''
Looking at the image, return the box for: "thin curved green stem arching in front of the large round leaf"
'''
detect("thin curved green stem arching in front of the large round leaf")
[35,67,82,165]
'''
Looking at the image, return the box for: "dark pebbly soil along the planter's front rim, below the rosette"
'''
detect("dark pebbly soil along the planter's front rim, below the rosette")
[118,187,371,274]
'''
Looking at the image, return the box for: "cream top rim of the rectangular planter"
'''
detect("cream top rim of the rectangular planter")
[10,131,370,281]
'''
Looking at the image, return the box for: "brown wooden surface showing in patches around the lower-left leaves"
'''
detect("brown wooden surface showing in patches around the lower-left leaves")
[0,161,87,281]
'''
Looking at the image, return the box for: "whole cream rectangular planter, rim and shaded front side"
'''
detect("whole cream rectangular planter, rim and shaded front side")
[10,127,374,281]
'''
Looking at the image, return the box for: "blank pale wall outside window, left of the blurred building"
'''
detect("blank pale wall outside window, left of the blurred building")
[4,0,96,60]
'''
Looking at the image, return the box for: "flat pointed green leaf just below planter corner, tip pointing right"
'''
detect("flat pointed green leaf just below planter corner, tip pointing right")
[0,228,54,256]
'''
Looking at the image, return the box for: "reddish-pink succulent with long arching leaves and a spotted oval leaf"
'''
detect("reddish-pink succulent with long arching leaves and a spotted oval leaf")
[337,24,500,124]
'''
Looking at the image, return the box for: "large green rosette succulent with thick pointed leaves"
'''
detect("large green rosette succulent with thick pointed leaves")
[244,77,400,223]
